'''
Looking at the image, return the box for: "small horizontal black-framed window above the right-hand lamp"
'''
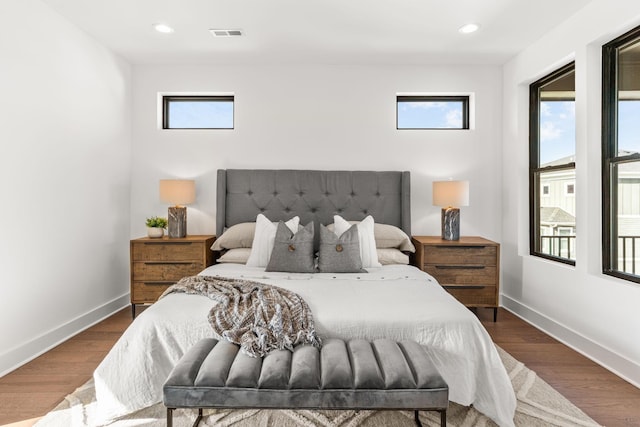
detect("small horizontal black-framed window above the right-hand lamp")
[396,95,469,129]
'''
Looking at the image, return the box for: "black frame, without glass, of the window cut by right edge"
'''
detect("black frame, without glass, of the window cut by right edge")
[602,26,640,283]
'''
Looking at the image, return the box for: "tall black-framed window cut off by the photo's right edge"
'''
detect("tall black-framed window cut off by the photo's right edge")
[602,27,640,283]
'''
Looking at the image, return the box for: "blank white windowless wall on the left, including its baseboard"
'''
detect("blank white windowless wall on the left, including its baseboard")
[0,0,131,375]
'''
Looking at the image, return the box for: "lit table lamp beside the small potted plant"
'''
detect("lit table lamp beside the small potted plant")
[160,179,196,237]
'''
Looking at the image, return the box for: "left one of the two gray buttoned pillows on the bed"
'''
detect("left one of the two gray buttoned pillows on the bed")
[266,221,316,273]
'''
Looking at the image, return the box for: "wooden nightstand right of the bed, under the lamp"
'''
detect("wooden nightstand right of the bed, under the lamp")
[412,236,500,322]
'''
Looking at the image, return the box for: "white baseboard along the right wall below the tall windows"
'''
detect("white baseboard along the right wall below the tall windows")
[502,295,640,388]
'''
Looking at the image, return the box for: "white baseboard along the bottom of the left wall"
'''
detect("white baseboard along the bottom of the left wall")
[0,293,130,377]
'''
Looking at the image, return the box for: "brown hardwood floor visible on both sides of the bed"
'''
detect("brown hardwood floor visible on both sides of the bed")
[0,307,640,427]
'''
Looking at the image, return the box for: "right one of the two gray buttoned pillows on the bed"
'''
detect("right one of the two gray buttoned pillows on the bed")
[318,225,367,273]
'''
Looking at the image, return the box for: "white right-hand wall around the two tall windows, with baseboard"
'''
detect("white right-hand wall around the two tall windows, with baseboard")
[502,0,640,385]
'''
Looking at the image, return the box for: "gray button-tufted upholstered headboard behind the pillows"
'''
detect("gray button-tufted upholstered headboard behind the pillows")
[216,169,411,236]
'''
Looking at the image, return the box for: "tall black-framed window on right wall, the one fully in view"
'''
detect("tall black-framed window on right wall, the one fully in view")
[529,63,576,264]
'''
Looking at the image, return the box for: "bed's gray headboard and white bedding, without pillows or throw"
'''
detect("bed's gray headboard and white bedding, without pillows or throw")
[94,169,516,426]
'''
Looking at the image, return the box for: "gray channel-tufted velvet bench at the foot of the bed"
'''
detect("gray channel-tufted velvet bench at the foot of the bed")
[163,338,449,427]
